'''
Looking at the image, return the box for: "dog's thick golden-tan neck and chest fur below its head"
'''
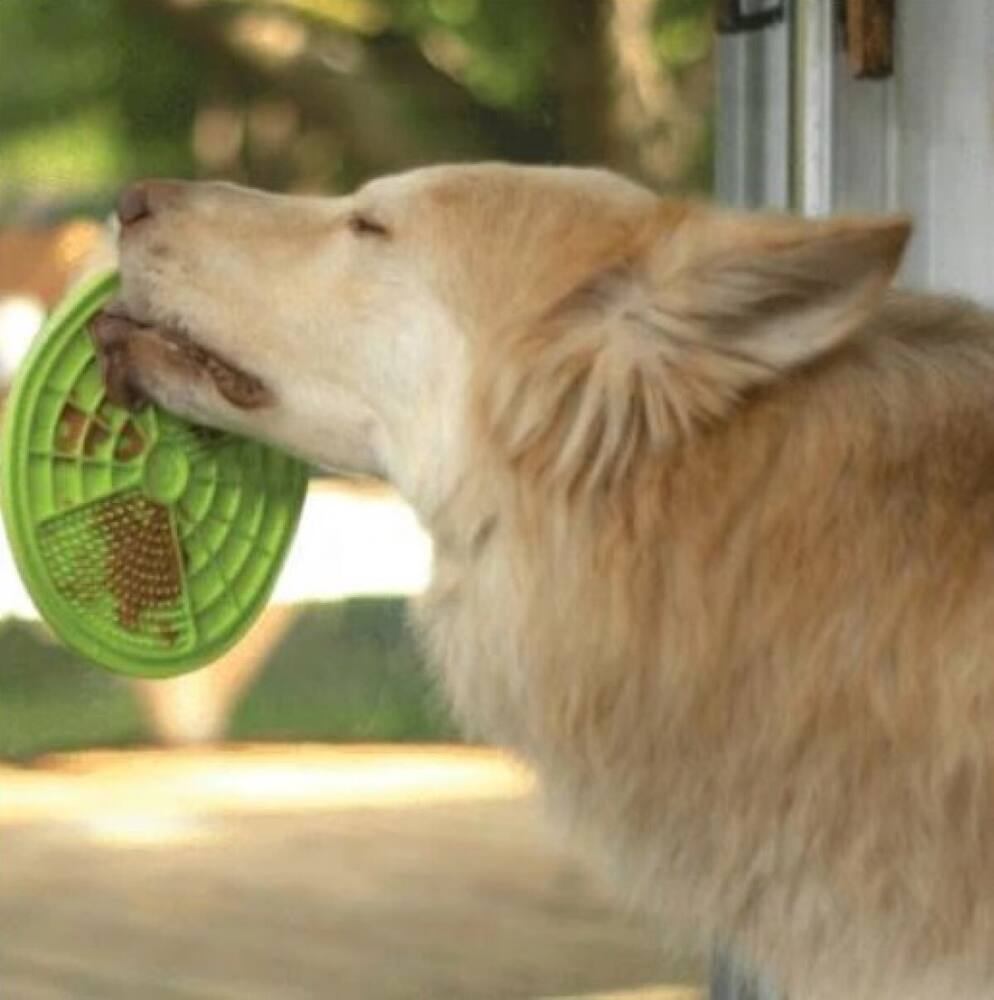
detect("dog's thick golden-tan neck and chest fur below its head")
[419,294,994,998]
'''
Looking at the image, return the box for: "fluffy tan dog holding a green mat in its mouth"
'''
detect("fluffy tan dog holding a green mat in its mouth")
[93,164,994,1000]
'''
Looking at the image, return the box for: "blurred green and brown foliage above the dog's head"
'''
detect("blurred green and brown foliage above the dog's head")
[0,0,712,220]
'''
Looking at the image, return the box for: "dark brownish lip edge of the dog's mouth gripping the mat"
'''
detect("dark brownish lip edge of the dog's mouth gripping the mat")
[89,312,271,410]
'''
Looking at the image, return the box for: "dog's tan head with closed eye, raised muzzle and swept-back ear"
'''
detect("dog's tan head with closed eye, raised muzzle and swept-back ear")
[96,165,908,505]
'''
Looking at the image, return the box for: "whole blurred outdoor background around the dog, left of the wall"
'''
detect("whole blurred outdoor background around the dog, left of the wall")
[0,0,714,1000]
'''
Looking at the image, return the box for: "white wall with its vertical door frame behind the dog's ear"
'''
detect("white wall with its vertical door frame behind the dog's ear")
[718,0,994,305]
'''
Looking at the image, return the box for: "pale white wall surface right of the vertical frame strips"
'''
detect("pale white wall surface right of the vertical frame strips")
[832,0,994,305]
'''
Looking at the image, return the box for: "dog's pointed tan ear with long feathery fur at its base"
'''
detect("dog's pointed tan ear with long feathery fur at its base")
[480,202,910,491]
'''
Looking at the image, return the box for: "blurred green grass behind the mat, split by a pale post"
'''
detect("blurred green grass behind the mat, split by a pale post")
[0,599,456,760]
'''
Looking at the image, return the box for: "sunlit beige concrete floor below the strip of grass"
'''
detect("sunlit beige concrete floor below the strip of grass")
[0,746,699,1000]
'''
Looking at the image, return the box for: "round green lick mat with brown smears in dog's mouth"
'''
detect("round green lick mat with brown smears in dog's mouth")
[0,273,307,677]
